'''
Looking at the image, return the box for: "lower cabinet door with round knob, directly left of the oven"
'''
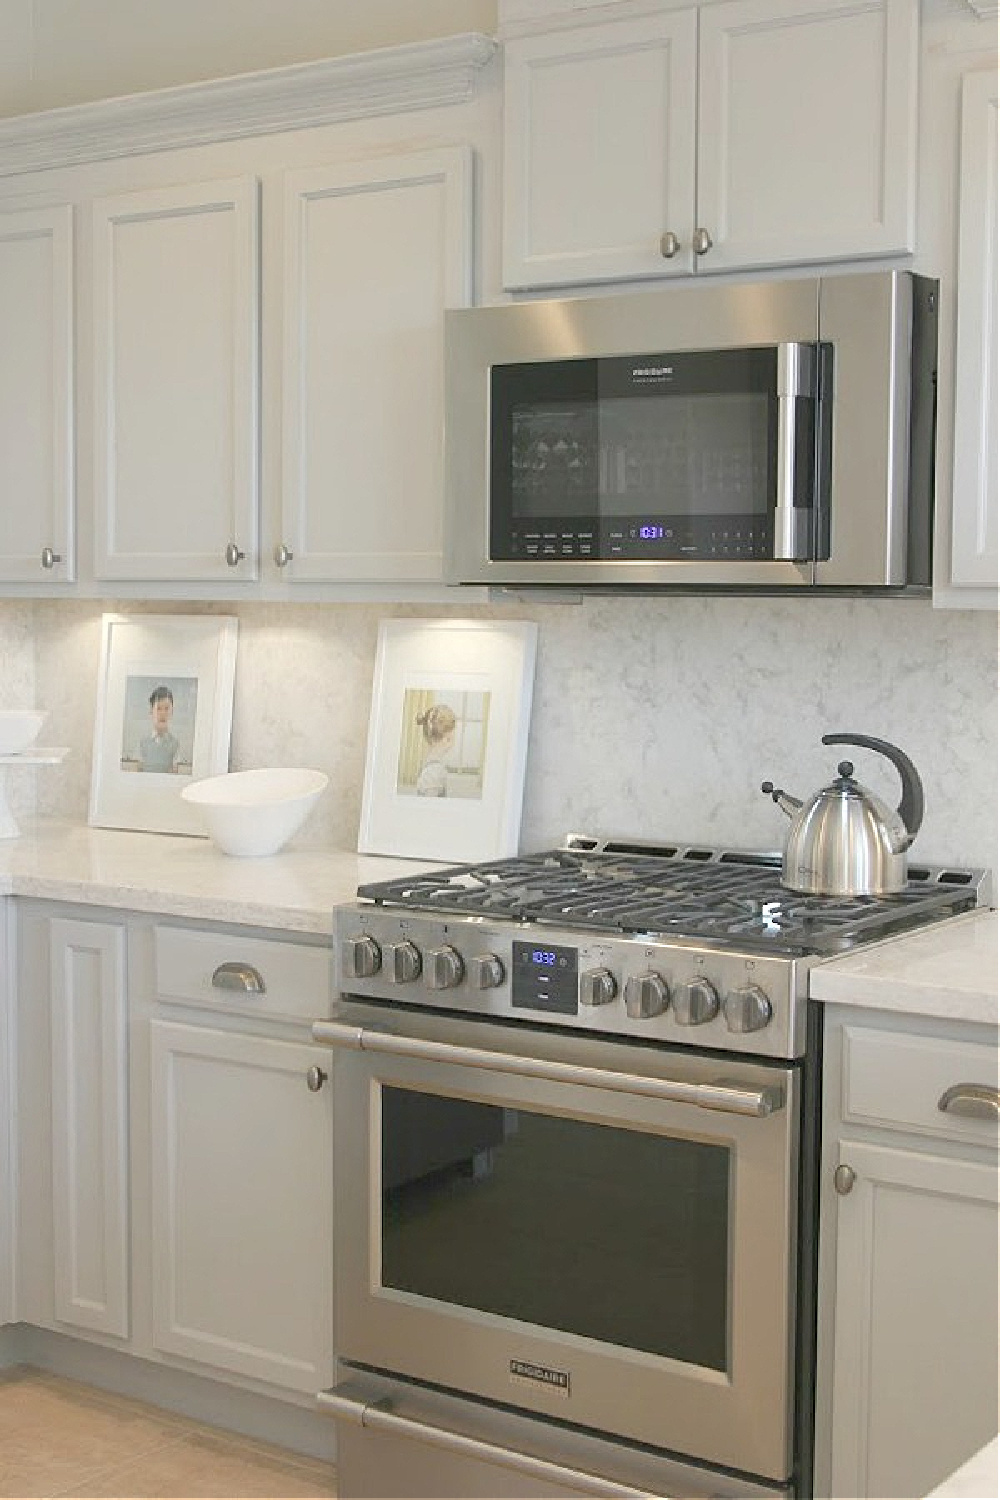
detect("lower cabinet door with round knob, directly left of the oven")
[150,1020,333,1392]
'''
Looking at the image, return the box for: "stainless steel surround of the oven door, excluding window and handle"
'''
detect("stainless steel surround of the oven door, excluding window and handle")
[325,1002,799,1485]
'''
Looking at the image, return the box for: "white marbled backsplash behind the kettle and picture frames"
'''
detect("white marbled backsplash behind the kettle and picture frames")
[0,597,997,869]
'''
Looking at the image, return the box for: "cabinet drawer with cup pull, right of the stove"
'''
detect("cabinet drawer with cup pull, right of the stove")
[843,1026,999,1146]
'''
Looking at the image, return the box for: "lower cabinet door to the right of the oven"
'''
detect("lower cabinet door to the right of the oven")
[832,1139,999,1497]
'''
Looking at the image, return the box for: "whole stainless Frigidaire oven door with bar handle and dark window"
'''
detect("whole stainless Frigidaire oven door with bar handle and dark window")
[313,1002,799,1484]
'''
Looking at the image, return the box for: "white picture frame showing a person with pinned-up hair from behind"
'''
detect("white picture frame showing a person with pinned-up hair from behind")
[358,620,538,864]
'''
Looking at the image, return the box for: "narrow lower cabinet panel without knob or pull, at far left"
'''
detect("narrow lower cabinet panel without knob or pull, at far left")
[15,903,130,1341]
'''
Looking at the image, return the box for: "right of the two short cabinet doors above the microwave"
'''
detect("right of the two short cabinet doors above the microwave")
[697,0,919,270]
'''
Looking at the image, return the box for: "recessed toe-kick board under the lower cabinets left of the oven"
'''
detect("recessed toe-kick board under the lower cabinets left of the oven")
[0,1323,336,1464]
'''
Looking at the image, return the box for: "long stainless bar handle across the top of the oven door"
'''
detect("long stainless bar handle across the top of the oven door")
[312,1022,784,1118]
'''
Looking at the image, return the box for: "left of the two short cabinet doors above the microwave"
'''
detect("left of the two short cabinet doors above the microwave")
[504,9,697,288]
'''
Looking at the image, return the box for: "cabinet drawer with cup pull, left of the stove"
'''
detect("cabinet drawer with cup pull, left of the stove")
[153,926,331,1020]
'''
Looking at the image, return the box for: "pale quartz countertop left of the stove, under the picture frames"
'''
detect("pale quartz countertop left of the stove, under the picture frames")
[0,819,442,936]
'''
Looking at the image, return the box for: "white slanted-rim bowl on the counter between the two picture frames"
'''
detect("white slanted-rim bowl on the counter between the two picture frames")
[180,768,330,855]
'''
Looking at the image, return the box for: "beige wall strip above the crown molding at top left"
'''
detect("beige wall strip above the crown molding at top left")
[0,0,496,116]
